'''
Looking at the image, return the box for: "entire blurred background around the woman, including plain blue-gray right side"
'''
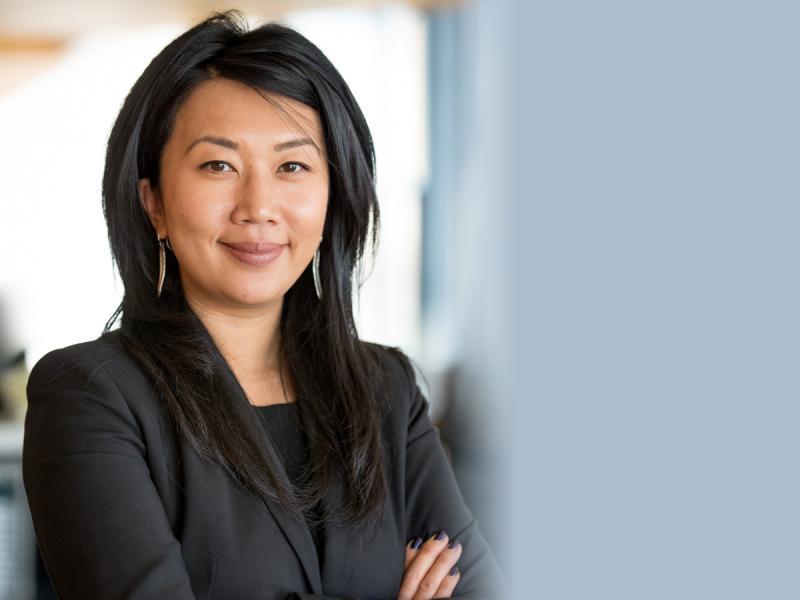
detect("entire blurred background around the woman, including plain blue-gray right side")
[0,0,800,600]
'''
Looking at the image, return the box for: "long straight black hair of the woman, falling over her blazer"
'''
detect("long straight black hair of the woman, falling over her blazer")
[103,10,388,526]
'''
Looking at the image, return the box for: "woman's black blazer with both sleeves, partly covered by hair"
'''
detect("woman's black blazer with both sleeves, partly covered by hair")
[23,332,506,600]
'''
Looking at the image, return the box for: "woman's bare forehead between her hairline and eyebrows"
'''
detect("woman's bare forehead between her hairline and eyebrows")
[172,78,323,147]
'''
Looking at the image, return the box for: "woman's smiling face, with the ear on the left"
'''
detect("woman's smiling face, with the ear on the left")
[139,79,328,311]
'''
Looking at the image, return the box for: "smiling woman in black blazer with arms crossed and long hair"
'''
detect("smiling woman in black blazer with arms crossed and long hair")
[23,11,501,600]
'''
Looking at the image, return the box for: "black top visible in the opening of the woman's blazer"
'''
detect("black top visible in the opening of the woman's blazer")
[255,402,325,568]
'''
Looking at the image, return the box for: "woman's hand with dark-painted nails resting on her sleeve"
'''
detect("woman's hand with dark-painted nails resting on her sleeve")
[397,531,462,600]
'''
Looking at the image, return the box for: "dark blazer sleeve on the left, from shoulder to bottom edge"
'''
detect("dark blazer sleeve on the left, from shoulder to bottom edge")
[22,349,194,600]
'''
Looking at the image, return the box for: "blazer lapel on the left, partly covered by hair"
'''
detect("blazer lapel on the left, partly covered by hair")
[198,326,322,594]
